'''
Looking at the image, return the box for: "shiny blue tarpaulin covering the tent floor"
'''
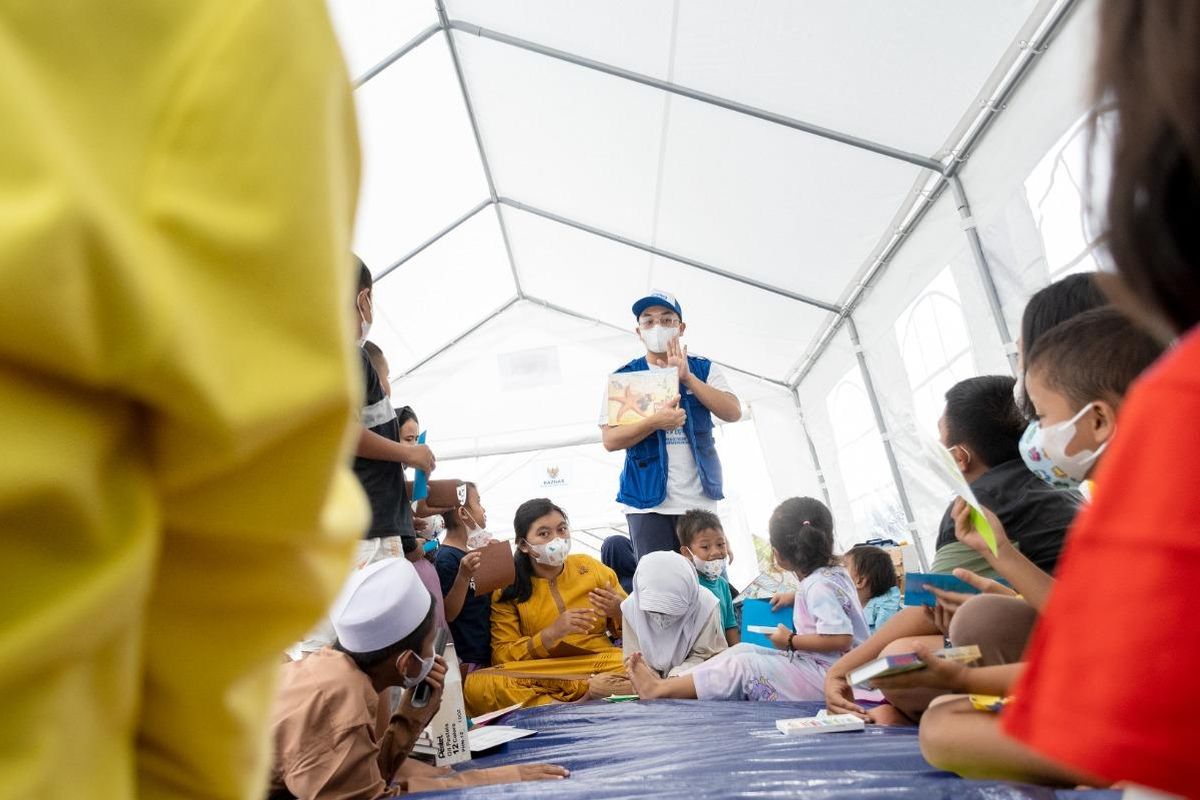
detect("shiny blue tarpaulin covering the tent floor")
[421,700,1121,800]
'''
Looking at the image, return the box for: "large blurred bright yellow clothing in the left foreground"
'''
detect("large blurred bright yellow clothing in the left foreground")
[0,0,367,800]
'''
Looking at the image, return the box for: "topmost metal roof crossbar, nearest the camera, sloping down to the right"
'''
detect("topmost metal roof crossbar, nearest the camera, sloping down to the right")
[445,19,946,173]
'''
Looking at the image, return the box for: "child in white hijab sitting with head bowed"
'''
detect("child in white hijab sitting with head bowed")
[620,552,728,676]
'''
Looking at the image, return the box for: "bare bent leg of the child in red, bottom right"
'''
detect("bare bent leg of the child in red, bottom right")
[920,696,1108,786]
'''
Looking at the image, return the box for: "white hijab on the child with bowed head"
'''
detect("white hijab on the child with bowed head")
[620,552,716,673]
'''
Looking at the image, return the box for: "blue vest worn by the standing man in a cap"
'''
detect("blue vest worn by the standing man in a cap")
[617,355,725,509]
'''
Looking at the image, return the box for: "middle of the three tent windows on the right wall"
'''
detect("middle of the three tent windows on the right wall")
[895,267,977,435]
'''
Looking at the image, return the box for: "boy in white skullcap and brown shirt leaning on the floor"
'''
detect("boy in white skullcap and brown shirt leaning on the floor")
[270,559,568,800]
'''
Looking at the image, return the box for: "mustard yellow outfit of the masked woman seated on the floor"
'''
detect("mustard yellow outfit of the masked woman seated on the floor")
[463,554,625,716]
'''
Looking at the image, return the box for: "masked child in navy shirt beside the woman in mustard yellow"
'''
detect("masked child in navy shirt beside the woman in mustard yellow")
[433,482,492,674]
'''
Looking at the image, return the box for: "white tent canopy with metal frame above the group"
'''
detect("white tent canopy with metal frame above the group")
[330,0,1093,582]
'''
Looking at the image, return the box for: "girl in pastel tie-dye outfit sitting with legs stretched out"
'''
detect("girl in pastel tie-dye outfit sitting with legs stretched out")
[628,498,868,700]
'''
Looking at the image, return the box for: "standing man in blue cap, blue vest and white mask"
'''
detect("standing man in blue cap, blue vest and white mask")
[600,291,742,559]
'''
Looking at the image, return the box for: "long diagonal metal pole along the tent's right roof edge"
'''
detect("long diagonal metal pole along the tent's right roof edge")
[788,0,1080,386]
